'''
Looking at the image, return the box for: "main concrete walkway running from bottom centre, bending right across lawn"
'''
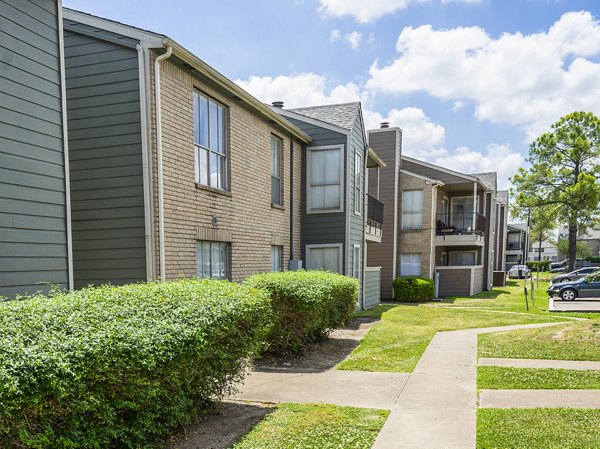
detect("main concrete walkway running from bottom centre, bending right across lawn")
[373,323,559,449]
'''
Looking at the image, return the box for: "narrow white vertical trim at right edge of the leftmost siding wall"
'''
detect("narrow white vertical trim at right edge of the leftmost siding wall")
[57,0,75,290]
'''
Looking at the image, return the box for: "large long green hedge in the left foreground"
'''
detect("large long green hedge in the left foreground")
[0,280,270,449]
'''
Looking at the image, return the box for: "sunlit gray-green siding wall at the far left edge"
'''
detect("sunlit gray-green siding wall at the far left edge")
[0,0,68,297]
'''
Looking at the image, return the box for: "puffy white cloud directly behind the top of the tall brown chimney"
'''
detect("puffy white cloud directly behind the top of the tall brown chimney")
[363,107,447,159]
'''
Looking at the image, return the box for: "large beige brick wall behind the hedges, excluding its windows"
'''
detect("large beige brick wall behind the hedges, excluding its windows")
[152,55,301,281]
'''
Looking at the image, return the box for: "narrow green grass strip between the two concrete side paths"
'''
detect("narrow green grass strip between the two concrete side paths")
[477,366,600,390]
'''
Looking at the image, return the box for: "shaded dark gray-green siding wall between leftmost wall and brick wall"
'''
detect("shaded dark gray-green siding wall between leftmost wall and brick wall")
[65,21,146,287]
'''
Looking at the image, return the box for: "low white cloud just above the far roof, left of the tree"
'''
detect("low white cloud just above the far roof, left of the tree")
[429,144,525,190]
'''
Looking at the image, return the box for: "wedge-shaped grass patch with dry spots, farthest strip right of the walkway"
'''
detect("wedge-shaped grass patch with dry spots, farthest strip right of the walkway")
[478,316,600,361]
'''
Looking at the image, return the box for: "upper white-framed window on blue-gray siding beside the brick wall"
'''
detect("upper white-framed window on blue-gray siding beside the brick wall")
[307,147,343,212]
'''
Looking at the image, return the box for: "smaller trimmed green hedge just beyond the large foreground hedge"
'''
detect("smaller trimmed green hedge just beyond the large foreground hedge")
[246,270,358,354]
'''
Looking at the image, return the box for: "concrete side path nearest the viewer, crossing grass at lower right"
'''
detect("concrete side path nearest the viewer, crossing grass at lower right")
[479,390,600,408]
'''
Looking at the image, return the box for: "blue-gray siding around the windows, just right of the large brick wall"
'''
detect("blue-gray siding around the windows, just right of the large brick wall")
[286,117,351,268]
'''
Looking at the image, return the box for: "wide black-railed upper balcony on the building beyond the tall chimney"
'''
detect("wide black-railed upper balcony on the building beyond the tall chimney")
[435,213,487,246]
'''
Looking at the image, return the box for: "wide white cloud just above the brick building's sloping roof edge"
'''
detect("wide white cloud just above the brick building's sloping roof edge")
[235,73,369,108]
